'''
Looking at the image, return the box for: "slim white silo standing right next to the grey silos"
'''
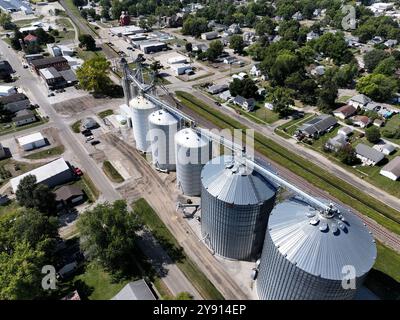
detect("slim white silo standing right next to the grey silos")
[175,128,211,196]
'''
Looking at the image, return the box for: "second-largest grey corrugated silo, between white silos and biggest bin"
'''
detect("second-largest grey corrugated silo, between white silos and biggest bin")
[201,156,276,261]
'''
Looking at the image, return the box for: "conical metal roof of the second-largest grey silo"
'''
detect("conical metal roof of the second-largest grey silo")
[201,155,276,205]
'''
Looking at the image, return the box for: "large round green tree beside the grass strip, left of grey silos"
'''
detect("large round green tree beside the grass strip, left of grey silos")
[77,200,139,276]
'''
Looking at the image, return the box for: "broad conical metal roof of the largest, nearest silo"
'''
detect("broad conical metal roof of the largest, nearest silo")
[268,198,377,280]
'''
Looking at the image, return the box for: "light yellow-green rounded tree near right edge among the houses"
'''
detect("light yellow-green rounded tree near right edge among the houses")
[356,73,398,101]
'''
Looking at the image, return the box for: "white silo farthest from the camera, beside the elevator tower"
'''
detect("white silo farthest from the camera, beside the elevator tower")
[129,96,158,152]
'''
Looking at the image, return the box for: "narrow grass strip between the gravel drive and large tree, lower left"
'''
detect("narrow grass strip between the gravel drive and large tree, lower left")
[132,199,223,300]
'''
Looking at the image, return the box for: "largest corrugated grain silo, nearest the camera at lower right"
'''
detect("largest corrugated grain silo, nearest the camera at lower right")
[257,198,376,300]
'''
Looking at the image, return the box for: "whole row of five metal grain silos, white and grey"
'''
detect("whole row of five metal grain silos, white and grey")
[124,93,376,300]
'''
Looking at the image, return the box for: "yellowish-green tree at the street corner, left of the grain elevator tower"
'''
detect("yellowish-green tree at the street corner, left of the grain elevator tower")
[76,57,112,94]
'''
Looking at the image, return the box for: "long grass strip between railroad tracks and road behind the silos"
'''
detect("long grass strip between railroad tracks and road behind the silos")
[177,92,400,234]
